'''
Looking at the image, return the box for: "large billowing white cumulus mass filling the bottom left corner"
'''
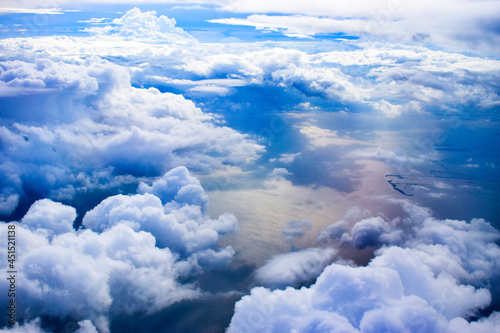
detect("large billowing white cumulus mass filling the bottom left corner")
[1,167,236,332]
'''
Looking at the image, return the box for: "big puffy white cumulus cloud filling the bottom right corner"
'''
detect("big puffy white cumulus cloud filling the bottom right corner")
[228,201,500,332]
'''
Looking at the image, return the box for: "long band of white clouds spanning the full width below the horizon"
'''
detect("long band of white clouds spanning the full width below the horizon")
[2,7,498,122]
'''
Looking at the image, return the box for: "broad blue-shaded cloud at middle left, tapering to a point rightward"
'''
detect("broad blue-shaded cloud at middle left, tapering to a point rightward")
[0,40,263,215]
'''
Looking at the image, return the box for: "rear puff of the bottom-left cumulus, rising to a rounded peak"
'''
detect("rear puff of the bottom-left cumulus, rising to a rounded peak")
[82,167,236,255]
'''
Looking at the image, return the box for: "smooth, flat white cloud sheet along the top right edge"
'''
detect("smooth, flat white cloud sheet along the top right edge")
[215,0,499,54]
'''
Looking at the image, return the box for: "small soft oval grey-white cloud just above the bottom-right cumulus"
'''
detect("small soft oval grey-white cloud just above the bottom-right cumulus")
[255,248,337,288]
